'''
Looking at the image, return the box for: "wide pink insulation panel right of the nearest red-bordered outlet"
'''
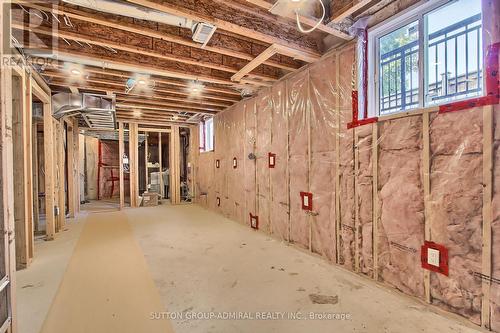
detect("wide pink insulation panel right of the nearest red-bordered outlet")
[429,109,483,324]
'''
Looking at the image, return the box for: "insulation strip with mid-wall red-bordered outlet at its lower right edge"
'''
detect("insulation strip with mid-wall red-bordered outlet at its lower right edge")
[287,71,314,248]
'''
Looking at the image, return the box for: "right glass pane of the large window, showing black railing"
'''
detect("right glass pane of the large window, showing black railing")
[424,0,483,105]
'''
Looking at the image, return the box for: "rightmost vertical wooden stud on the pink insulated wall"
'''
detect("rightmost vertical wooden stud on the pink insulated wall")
[481,105,494,329]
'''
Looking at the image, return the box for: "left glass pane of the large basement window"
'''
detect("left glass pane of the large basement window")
[379,21,419,114]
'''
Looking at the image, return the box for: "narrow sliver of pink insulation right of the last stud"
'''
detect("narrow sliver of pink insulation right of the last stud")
[490,105,500,332]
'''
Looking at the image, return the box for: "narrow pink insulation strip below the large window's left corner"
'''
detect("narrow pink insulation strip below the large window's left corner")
[356,125,376,276]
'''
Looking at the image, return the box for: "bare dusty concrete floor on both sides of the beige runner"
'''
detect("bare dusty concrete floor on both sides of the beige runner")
[17,205,482,333]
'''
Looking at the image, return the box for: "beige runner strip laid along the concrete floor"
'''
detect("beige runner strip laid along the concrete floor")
[41,212,173,333]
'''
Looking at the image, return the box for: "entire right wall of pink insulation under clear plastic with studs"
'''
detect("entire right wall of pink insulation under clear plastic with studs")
[195,44,500,332]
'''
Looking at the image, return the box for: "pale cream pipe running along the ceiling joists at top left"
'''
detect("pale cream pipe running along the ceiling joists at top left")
[63,0,193,29]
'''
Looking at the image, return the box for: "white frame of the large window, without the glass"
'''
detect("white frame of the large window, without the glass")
[368,0,486,117]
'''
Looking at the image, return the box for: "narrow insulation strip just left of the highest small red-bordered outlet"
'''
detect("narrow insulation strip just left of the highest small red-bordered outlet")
[255,89,273,234]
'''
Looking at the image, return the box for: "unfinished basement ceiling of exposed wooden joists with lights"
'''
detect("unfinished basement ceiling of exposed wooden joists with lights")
[12,0,382,124]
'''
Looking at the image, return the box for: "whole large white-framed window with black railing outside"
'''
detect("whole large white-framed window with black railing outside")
[369,0,483,115]
